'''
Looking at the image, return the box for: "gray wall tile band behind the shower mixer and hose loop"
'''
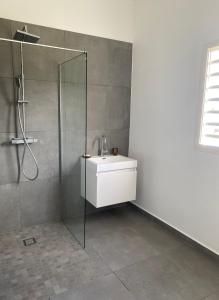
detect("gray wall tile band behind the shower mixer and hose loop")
[0,131,59,185]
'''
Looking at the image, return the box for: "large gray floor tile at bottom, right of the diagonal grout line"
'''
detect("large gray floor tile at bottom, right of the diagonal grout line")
[117,255,200,300]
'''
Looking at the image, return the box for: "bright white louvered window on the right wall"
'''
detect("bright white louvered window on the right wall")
[199,47,219,147]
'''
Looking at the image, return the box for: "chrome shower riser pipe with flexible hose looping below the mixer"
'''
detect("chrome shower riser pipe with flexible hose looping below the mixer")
[17,43,39,181]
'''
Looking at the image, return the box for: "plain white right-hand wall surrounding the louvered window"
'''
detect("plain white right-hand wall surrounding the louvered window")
[130,0,219,253]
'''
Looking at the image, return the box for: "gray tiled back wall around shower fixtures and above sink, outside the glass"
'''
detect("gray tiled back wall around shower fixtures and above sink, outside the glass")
[0,19,132,231]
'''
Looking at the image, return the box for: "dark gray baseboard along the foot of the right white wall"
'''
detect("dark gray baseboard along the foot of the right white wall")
[129,202,219,260]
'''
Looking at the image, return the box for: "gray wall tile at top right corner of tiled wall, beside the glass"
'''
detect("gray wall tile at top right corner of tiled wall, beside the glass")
[65,31,132,87]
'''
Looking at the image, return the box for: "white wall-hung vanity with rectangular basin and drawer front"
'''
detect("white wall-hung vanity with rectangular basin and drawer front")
[81,155,137,207]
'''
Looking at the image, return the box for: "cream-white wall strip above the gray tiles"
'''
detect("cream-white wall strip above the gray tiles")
[0,0,134,42]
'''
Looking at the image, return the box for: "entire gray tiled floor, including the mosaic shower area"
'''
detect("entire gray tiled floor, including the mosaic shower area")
[0,207,219,300]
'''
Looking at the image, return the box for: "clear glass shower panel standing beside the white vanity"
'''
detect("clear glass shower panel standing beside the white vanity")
[59,53,87,247]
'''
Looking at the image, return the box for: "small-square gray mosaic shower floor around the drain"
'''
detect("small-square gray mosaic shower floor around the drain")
[0,223,110,300]
